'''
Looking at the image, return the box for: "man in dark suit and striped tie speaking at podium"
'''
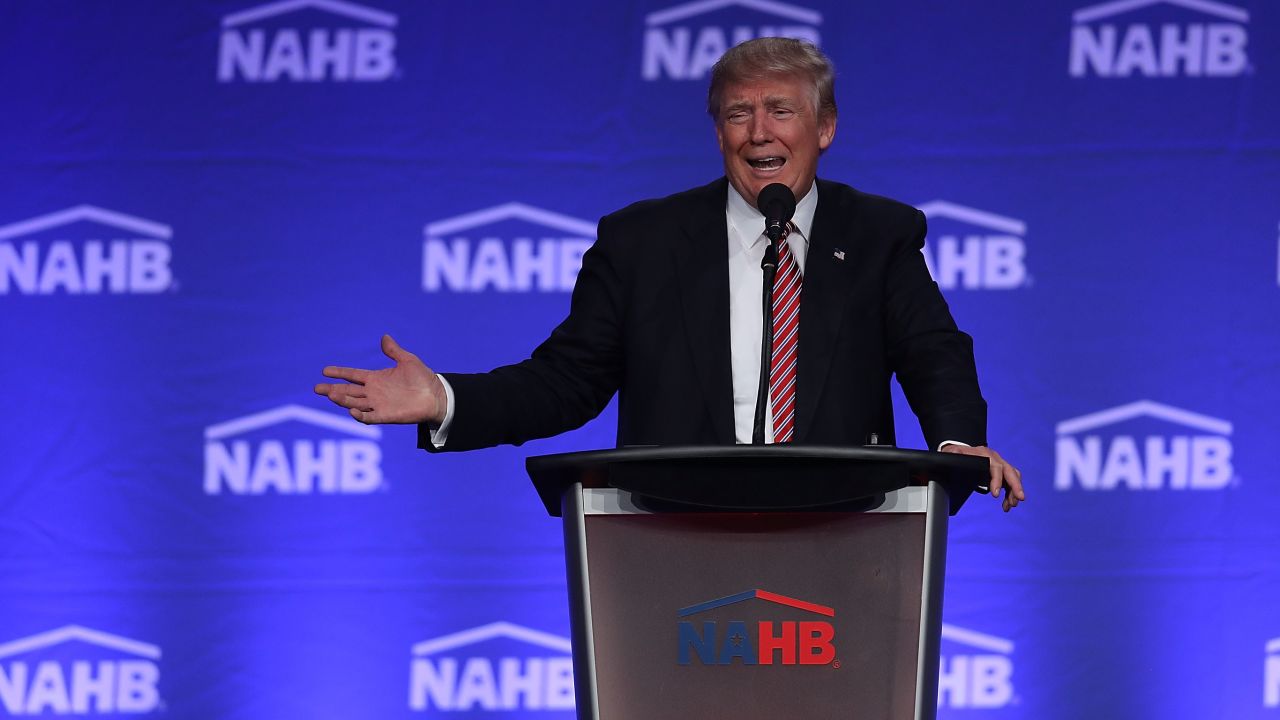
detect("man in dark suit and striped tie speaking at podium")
[315,37,1025,511]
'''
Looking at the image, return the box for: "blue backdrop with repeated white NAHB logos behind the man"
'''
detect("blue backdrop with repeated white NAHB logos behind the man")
[0,0,1280,720]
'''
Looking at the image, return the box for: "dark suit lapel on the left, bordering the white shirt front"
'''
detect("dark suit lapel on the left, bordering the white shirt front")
[673,179,733,445]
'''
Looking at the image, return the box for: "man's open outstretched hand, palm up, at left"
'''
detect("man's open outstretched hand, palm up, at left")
[315,334,447,424]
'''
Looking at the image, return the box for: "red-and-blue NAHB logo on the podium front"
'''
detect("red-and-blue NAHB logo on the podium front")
[676,589,840,667]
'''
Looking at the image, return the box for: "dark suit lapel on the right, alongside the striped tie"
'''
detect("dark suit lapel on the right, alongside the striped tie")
[795,181,855,442]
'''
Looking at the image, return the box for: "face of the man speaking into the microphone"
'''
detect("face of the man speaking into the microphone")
[716,77,836,206]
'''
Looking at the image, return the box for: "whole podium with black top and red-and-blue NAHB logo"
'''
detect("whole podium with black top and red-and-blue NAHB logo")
[527,446,988,720]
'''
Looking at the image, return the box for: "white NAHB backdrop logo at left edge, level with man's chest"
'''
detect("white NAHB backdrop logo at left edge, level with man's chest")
[0,205,174,295]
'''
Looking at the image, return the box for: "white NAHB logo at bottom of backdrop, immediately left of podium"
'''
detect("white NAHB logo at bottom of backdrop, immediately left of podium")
[408,623,573,717]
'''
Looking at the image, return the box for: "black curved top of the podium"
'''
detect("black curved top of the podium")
[525,445,991,516]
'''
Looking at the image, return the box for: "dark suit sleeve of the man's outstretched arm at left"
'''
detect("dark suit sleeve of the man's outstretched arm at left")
[419,218,626,452]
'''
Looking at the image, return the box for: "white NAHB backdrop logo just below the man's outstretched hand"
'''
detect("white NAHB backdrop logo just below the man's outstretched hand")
[205,397,383,495]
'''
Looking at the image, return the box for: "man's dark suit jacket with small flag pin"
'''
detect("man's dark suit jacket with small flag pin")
[420,178,987,451]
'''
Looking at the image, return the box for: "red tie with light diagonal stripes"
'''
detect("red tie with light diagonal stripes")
[769,223,800,442]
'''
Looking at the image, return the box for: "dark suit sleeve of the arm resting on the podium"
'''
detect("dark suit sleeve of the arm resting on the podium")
[884,210,987,450]
